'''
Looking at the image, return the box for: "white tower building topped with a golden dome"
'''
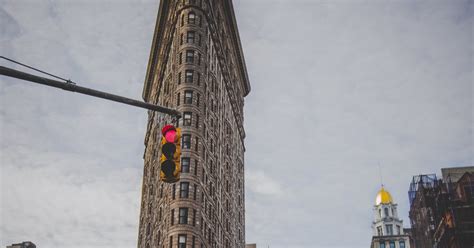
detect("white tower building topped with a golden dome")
[370,186,410,248]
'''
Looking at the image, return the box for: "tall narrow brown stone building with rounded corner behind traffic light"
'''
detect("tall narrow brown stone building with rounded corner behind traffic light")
[138,0,250,248]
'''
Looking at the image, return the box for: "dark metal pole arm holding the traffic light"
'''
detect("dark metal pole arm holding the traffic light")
[0,66,181,118]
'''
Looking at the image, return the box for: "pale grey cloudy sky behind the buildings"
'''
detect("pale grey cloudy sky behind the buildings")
[0,0,474,248]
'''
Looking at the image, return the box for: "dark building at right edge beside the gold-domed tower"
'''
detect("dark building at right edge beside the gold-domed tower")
[408,166,474,248]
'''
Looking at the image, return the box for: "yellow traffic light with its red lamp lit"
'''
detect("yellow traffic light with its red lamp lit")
[160,125,181,183]
